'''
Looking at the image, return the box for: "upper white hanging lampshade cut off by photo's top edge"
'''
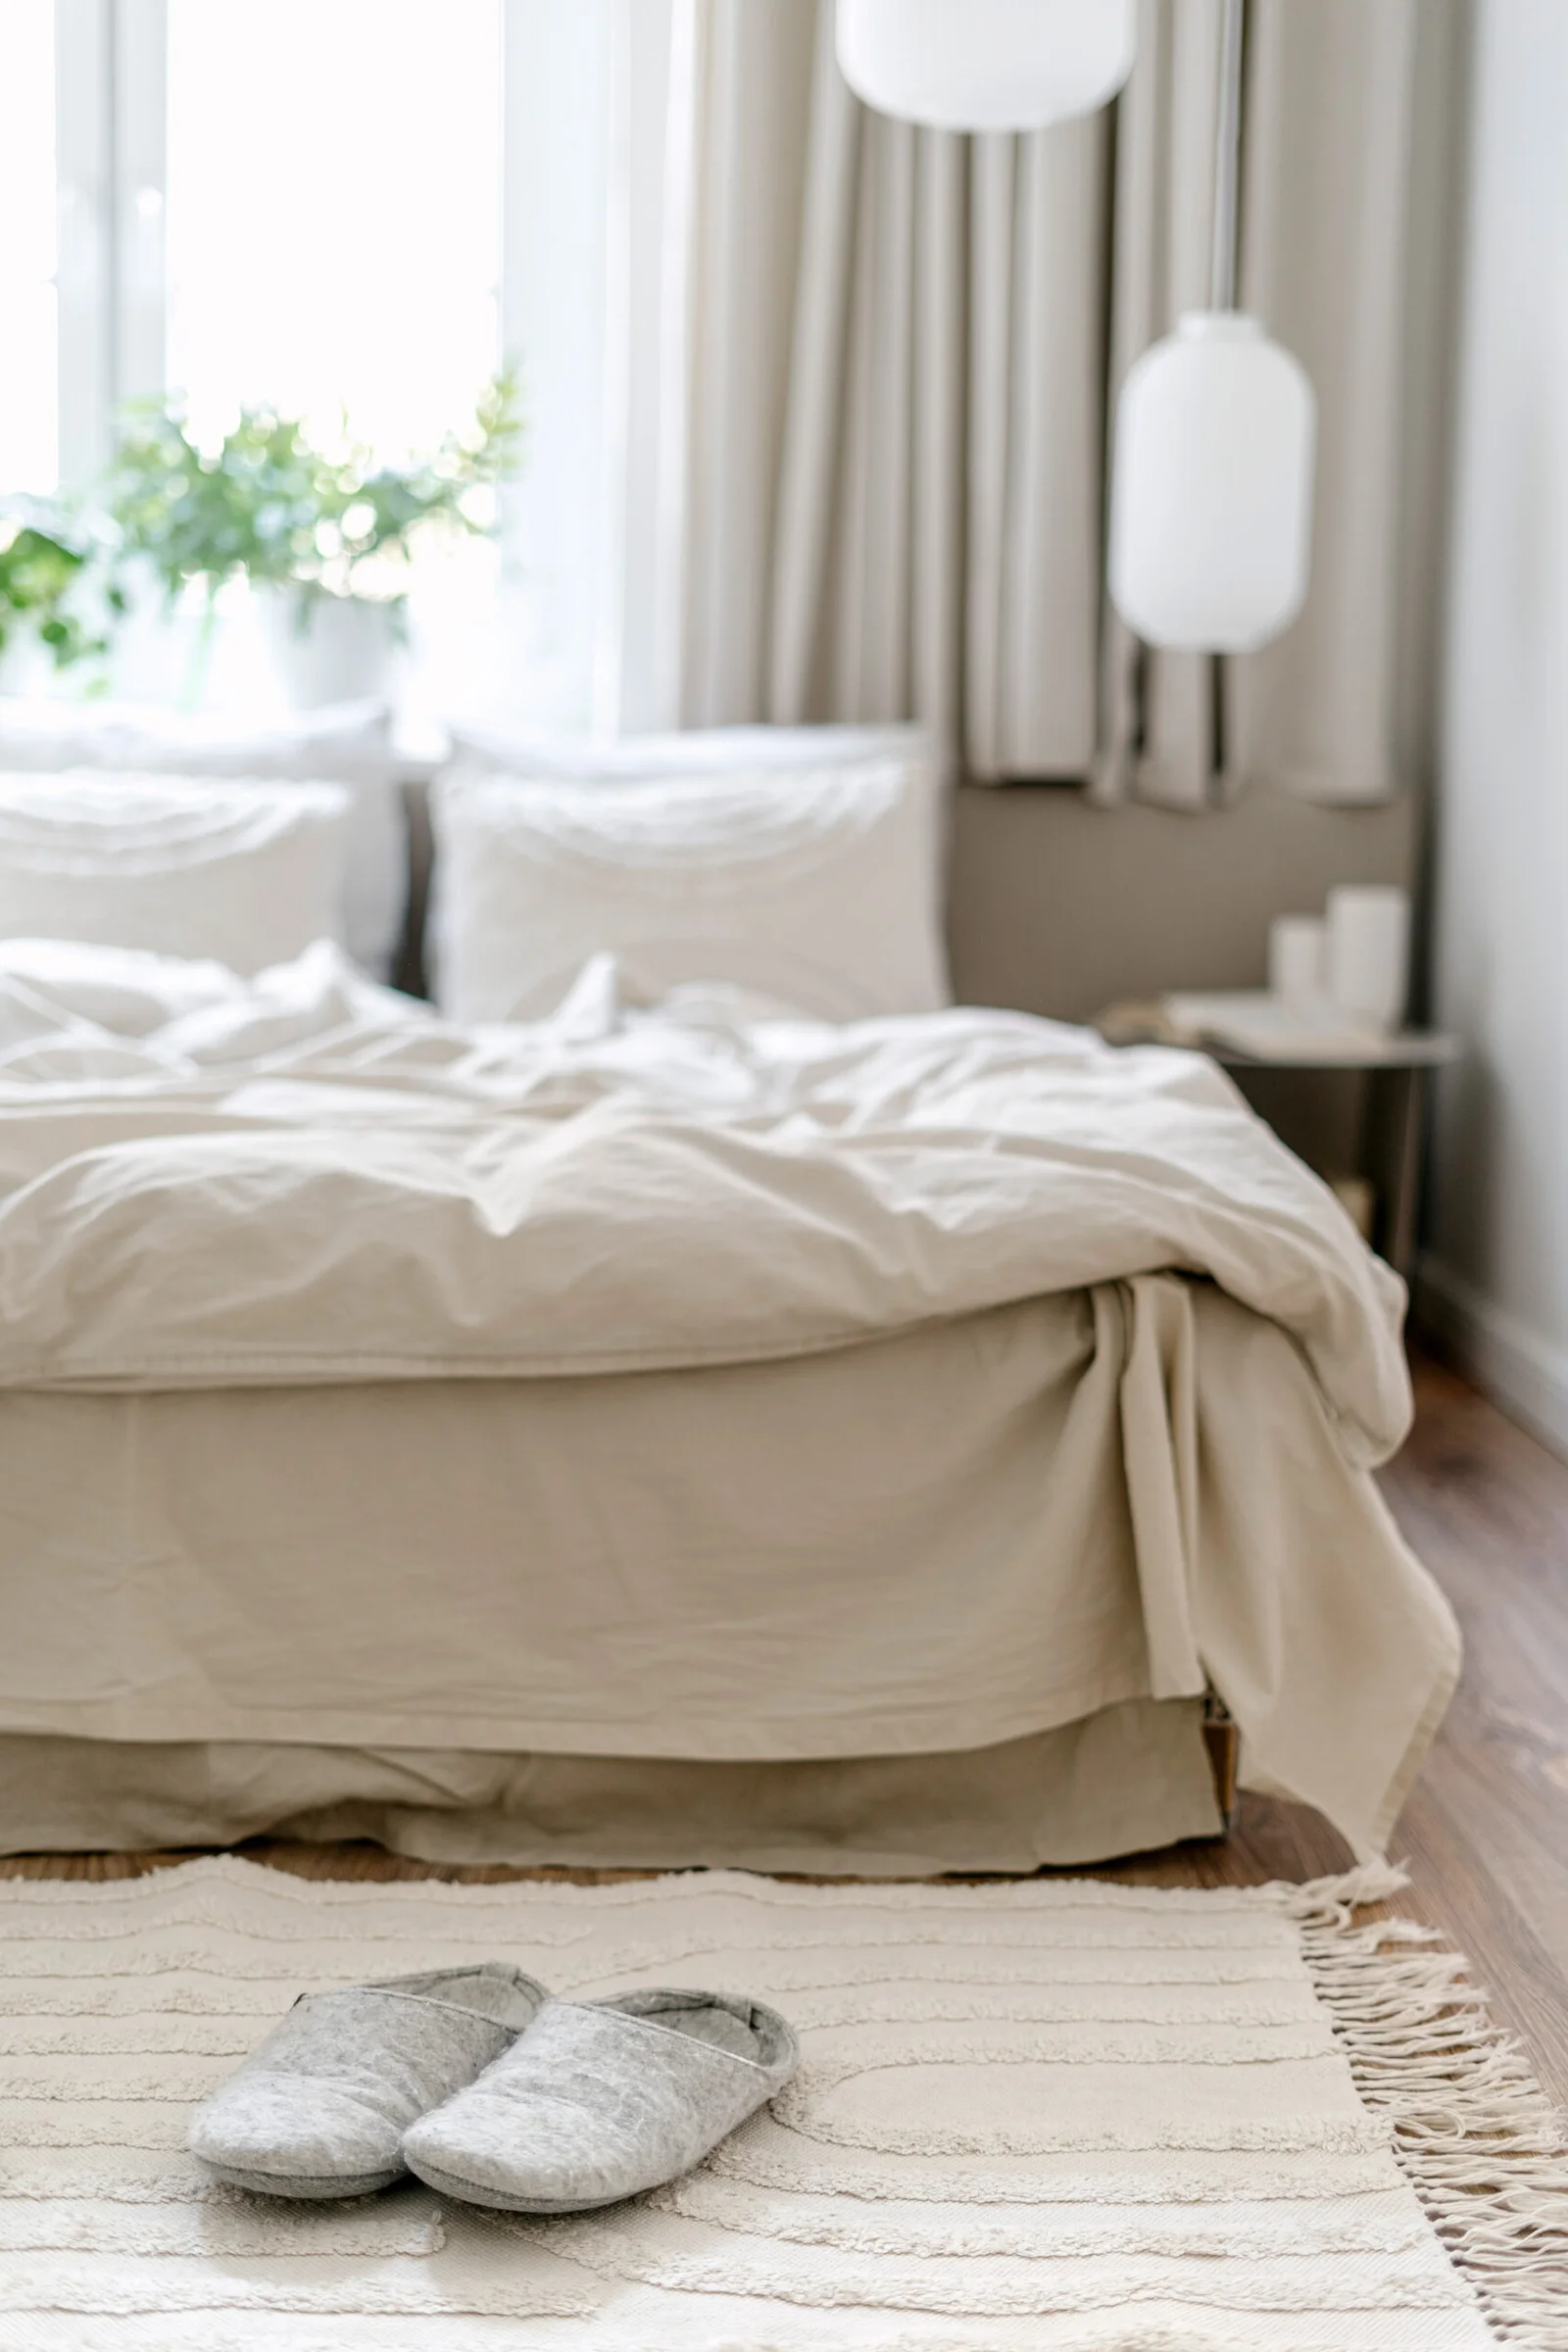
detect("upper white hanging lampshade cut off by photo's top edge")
[837,0,1138,131]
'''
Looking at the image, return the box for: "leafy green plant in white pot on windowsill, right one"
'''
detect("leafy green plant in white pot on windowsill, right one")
[111,367,522,708]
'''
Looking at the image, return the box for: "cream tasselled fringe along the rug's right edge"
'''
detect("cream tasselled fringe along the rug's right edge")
[1286,1863,1568,2352]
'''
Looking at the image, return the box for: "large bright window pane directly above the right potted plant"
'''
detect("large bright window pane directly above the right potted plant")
[165,0,501,457]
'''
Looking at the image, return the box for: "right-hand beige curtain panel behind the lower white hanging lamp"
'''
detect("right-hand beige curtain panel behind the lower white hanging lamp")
[1093,0,1444,807]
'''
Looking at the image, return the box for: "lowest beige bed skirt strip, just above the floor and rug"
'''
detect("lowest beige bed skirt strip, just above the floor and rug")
[0,1700,1225,1877]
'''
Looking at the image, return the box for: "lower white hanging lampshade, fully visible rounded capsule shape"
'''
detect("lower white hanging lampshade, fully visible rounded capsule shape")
[1109,311,1316,654]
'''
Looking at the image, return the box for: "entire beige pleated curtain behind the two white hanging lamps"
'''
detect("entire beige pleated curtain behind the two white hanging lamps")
[632,0,1450,809]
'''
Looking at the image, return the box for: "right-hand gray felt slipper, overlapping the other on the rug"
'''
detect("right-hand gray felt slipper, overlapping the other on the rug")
[402,1989,800,2213]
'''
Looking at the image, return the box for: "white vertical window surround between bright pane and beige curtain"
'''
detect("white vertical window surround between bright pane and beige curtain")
[501,0,698,736]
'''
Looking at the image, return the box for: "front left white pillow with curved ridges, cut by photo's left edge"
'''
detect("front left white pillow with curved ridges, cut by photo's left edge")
[0,771,350,974]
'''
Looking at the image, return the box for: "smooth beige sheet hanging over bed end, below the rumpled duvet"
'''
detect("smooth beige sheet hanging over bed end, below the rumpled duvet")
[0,1275,1457,1848]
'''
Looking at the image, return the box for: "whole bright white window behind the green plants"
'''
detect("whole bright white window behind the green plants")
[0,0,615,722]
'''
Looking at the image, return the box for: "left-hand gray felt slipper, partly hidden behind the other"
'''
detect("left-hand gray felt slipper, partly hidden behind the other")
[188,1959,550,2197]
